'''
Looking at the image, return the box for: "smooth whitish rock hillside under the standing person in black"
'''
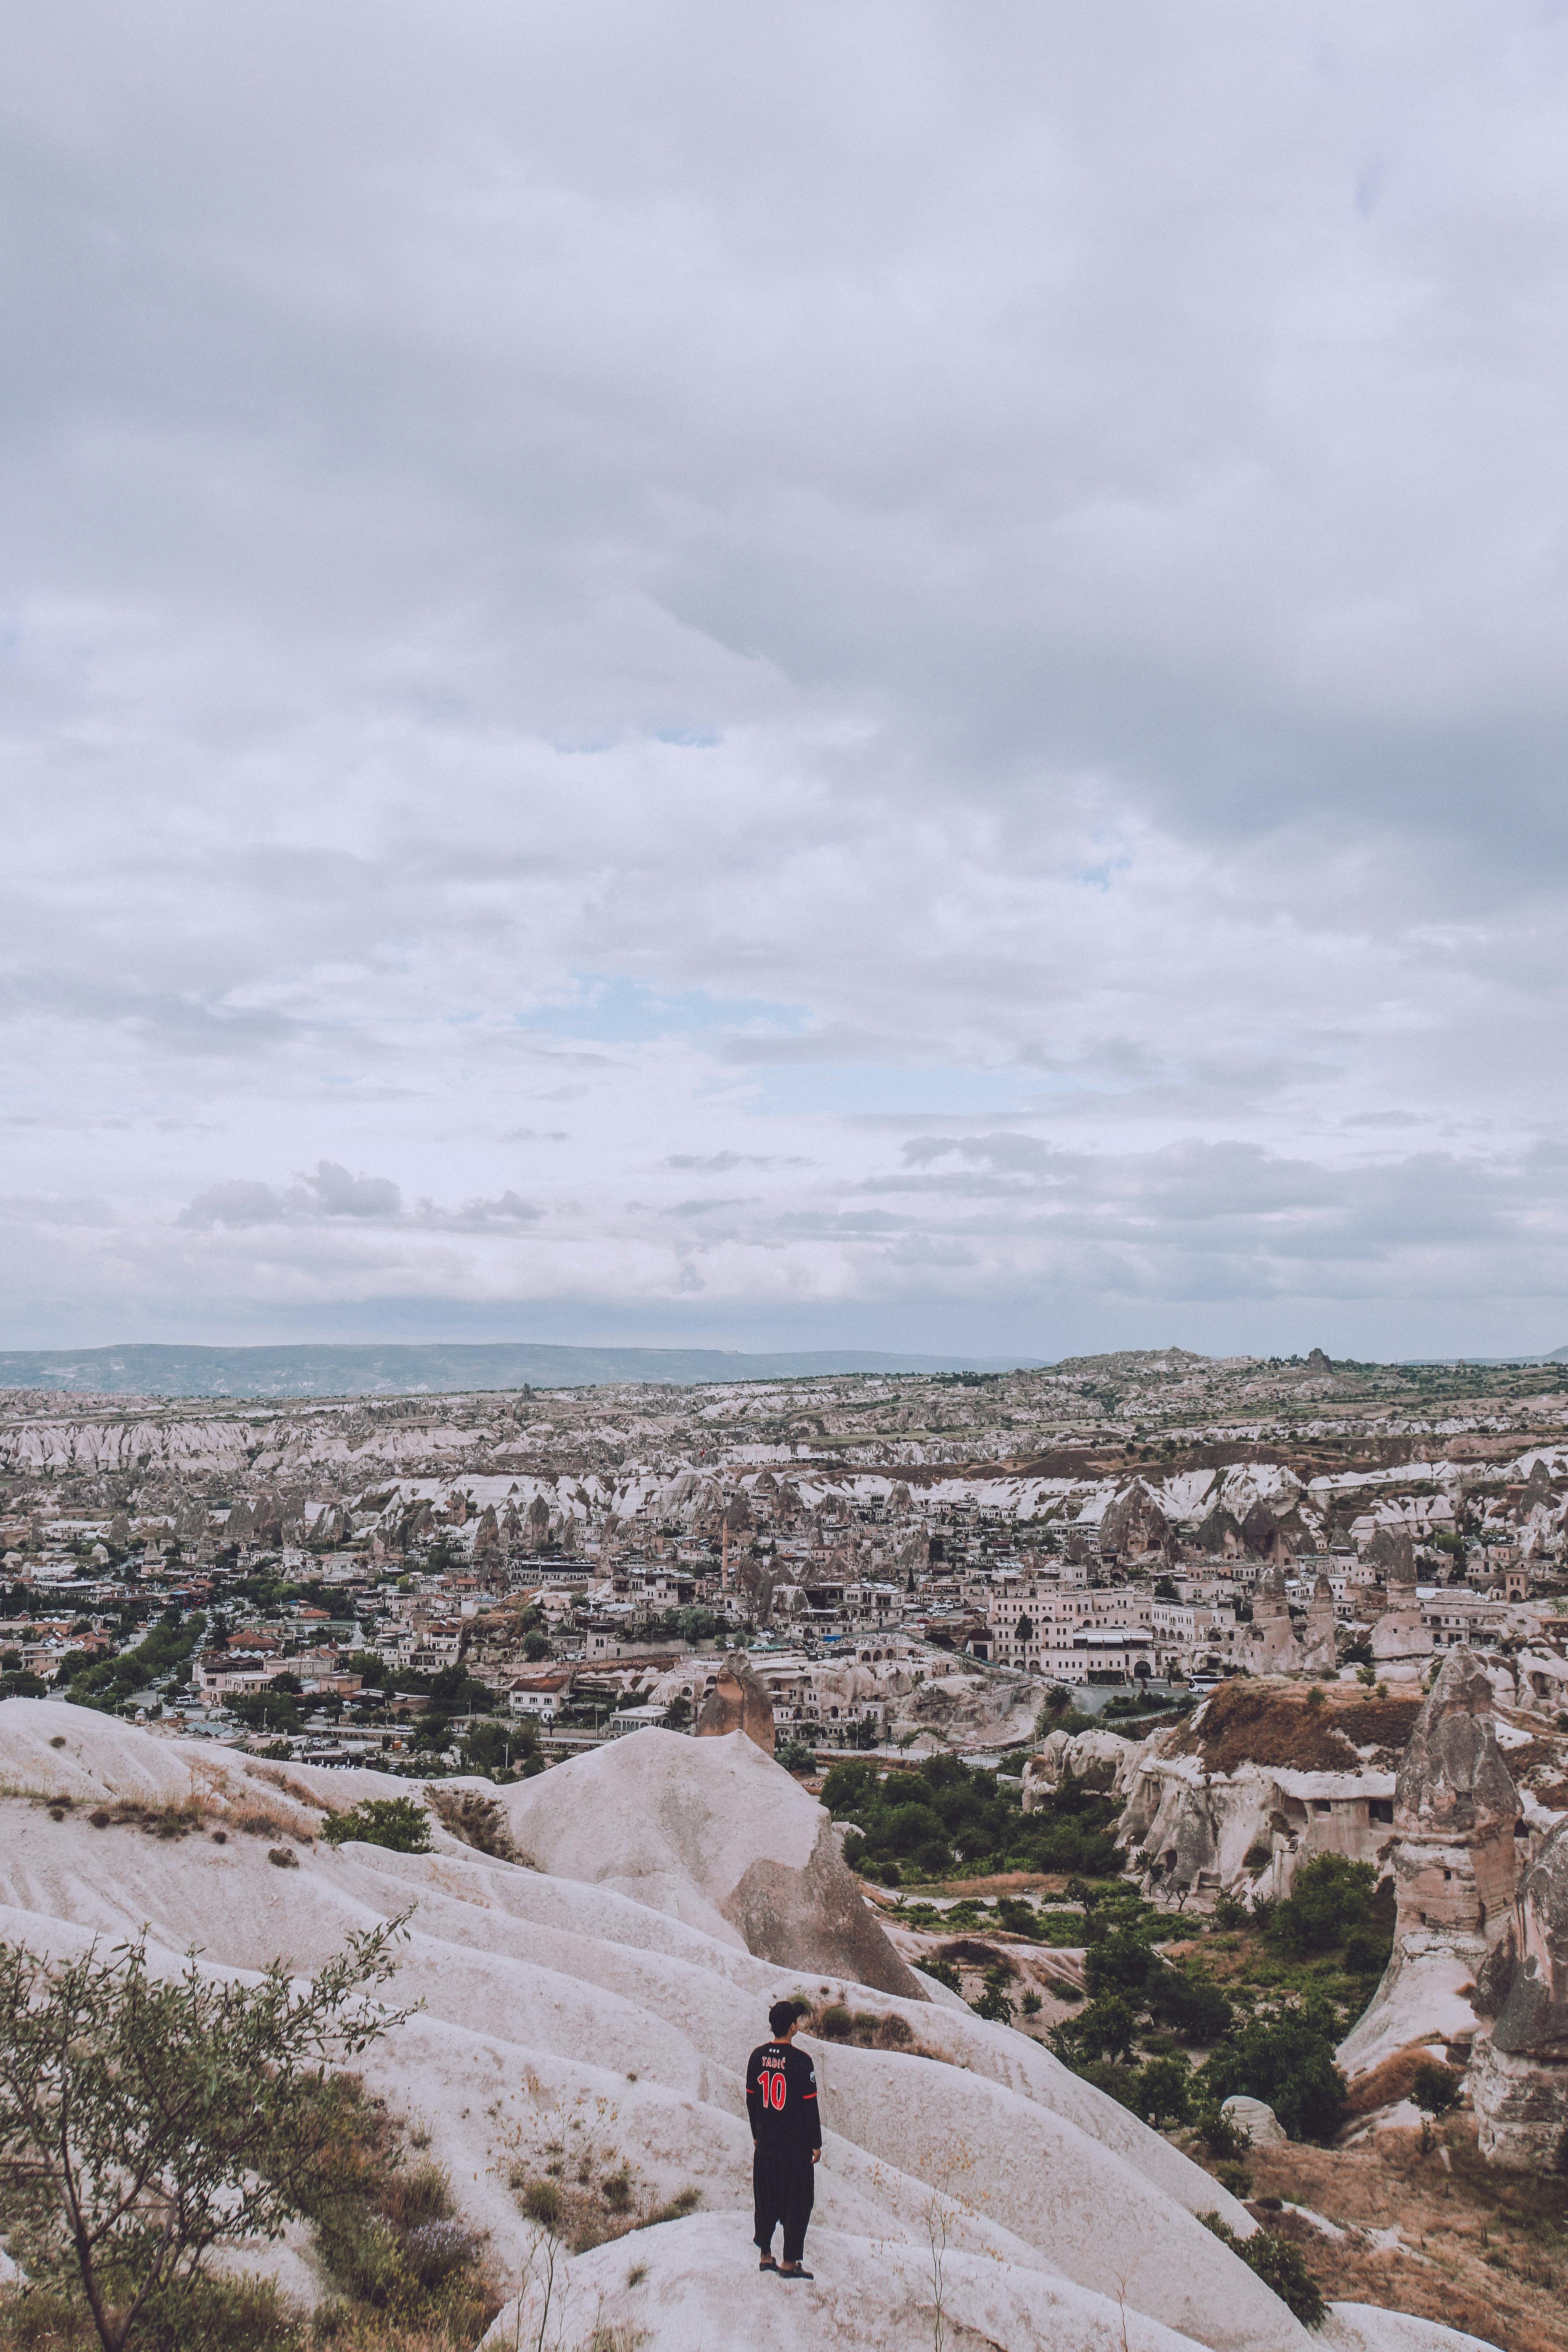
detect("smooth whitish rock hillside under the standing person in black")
[0,1701,1505,2352]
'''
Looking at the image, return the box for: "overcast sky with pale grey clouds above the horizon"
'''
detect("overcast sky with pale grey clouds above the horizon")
[0,0,1568,1357]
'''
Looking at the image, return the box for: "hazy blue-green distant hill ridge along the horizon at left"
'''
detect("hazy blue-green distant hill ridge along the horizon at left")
[0,1341,1039,1397]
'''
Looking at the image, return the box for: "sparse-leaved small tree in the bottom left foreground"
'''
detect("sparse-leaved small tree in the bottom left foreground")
[0,1919,402,2352]
